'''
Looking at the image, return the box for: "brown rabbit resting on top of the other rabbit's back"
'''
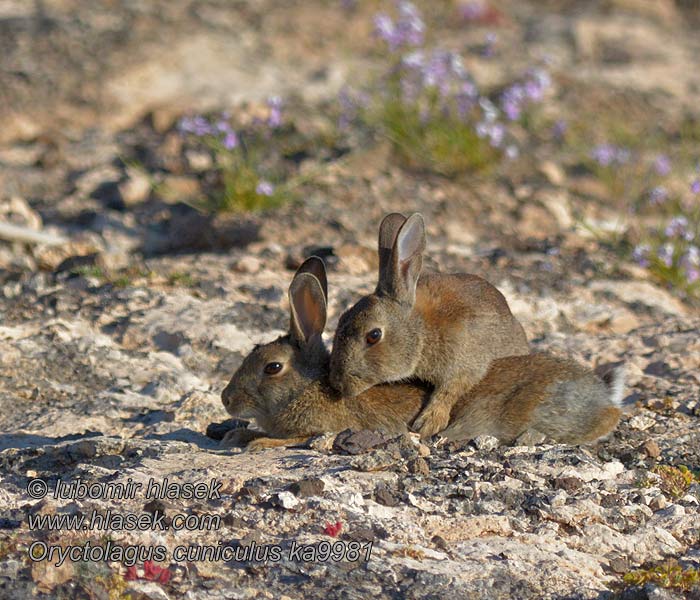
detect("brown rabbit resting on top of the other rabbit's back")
[330,213,530,438]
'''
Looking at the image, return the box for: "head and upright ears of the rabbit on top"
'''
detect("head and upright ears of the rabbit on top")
[330,213,425,397]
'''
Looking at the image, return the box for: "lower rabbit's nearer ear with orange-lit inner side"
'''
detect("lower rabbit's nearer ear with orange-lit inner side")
[289,273,326,347]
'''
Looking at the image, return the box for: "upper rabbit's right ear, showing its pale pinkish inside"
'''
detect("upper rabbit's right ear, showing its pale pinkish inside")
[377,213,425,305]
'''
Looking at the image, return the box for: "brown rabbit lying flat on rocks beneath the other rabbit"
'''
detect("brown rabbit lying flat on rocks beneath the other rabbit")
[221,257,623,449]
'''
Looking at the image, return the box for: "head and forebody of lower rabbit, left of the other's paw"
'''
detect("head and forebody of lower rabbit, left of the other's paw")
[221,257,429,449]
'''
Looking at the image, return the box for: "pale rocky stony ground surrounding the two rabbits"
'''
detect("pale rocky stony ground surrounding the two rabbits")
[0,0,700,600]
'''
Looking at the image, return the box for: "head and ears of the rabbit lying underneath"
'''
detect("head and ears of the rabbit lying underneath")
[221,256,329,428]
